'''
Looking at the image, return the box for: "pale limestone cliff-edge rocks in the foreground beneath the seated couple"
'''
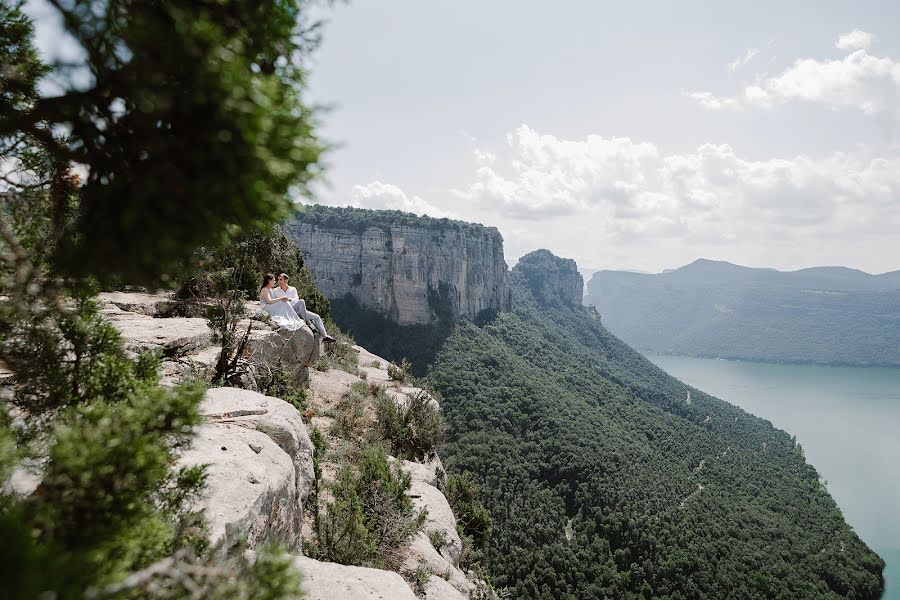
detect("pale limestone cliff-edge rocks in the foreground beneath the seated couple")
[93,293,486,600]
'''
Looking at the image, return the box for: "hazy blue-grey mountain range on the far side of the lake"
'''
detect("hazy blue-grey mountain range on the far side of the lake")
[585,259,900,366]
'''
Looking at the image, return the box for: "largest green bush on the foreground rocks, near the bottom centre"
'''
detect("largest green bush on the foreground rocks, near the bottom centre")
[313,445,425,569]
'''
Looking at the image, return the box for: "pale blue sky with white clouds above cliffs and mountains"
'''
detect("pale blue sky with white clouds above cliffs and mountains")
[309,0,900,275]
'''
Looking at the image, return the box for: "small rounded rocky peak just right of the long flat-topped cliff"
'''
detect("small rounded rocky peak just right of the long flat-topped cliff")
[513,250,584,306]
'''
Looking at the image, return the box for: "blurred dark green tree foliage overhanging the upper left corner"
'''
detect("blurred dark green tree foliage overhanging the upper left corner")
[0,0,322,283]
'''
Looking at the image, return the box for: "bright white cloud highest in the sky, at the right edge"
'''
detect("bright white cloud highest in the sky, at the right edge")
[687,30,900,120]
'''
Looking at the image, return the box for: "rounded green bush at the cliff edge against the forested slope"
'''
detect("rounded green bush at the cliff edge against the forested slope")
[375,391,444,460]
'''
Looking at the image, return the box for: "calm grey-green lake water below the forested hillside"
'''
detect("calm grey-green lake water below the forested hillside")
[647,354,900,600]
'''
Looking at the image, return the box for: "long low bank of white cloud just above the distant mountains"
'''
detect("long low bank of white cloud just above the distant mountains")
[455,125,900,244]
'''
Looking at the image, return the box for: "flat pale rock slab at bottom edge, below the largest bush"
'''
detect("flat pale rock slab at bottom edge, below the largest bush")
[294,556,416,600]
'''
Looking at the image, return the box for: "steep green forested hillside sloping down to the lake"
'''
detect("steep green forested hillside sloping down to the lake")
[429,252,884,600]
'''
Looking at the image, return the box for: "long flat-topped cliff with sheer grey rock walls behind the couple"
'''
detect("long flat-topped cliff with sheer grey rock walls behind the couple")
[286,206,510,325]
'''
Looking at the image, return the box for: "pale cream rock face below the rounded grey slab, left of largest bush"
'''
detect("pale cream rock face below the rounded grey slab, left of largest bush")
[179,423,300,553]
